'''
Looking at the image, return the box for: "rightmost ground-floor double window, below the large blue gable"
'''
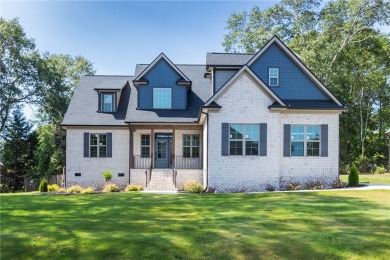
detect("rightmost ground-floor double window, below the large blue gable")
[291,125,321,156]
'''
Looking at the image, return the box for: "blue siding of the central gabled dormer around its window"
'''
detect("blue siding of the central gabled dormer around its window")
[138,59,187,110]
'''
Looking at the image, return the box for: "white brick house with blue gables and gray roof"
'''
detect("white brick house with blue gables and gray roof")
[62,37,345,191]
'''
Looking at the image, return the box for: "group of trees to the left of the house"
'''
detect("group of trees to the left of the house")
[0,18,95,191]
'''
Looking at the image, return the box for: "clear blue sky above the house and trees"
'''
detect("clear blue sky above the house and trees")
[1,1,277,75]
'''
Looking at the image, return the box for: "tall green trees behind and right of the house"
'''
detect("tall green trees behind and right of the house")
[223,0,390,172]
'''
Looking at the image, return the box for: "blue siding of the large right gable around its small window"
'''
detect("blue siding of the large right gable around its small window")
[250,42,329,100]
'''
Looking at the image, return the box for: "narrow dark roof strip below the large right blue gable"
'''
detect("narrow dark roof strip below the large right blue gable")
[270,99,345,110]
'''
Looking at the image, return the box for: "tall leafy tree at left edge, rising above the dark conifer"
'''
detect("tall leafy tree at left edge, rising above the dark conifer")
[0,18,39,134]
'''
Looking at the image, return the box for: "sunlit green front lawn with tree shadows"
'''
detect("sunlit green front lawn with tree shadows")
[0,190,390,259]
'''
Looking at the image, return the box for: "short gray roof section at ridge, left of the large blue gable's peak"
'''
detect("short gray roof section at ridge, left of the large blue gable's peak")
[206,52,254,66]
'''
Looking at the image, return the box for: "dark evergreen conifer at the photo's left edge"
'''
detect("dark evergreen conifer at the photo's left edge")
[1,105,34,191]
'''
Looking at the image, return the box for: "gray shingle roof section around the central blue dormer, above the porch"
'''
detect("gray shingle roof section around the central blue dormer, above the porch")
[126,64,211,123]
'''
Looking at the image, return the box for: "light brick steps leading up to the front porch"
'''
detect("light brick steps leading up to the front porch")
[144,169,177,191]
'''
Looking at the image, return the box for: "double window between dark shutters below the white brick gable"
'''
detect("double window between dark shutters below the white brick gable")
[229,124,260,155]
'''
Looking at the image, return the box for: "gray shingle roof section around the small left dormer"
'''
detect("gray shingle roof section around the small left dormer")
[62,76,133,126]
